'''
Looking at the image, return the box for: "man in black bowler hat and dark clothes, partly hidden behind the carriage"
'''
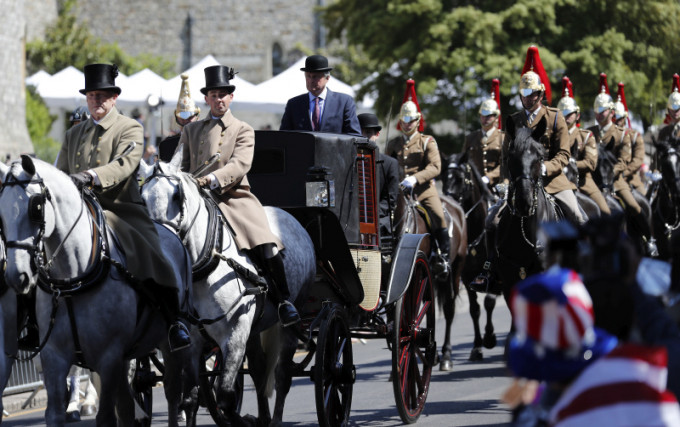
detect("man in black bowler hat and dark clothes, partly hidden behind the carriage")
[358,113,399,235]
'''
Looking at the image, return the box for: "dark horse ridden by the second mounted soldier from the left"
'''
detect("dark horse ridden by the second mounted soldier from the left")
[443,153,497,361]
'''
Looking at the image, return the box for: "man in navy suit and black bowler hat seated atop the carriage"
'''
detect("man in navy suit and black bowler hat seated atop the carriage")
[279,55,361,135]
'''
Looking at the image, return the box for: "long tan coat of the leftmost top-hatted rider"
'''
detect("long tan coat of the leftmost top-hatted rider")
[57,107,179,289]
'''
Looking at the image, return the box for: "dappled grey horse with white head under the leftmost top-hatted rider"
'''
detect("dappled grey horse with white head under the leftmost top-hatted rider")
[0,156,191,426]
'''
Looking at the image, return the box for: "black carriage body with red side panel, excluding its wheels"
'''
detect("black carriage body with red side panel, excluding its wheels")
[248,131,381,310]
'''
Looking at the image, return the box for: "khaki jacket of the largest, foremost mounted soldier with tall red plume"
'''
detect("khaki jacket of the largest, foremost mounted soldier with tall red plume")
[503,105,575,194]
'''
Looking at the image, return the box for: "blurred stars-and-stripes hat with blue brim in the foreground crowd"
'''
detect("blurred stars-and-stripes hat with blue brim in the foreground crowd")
[508,267,617,381]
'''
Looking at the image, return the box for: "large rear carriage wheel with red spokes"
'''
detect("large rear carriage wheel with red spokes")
[392,252,437,424]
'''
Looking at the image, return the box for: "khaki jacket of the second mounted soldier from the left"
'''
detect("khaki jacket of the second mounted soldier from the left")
[463,128,504,188]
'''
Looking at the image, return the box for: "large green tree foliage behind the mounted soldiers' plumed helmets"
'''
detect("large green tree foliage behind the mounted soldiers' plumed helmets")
[322,0,680,150]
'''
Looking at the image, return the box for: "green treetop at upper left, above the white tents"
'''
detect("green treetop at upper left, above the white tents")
[26,0,174,78]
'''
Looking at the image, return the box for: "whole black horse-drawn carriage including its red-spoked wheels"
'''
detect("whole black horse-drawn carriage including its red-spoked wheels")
[248,131,437,425]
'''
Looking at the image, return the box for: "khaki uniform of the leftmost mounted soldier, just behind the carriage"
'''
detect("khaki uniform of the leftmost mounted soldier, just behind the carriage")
[385,131,446,231]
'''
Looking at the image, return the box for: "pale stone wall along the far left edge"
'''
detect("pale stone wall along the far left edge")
[0,0,33,161]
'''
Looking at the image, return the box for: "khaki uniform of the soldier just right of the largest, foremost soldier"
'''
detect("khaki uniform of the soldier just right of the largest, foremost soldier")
[571,128,611,215]
